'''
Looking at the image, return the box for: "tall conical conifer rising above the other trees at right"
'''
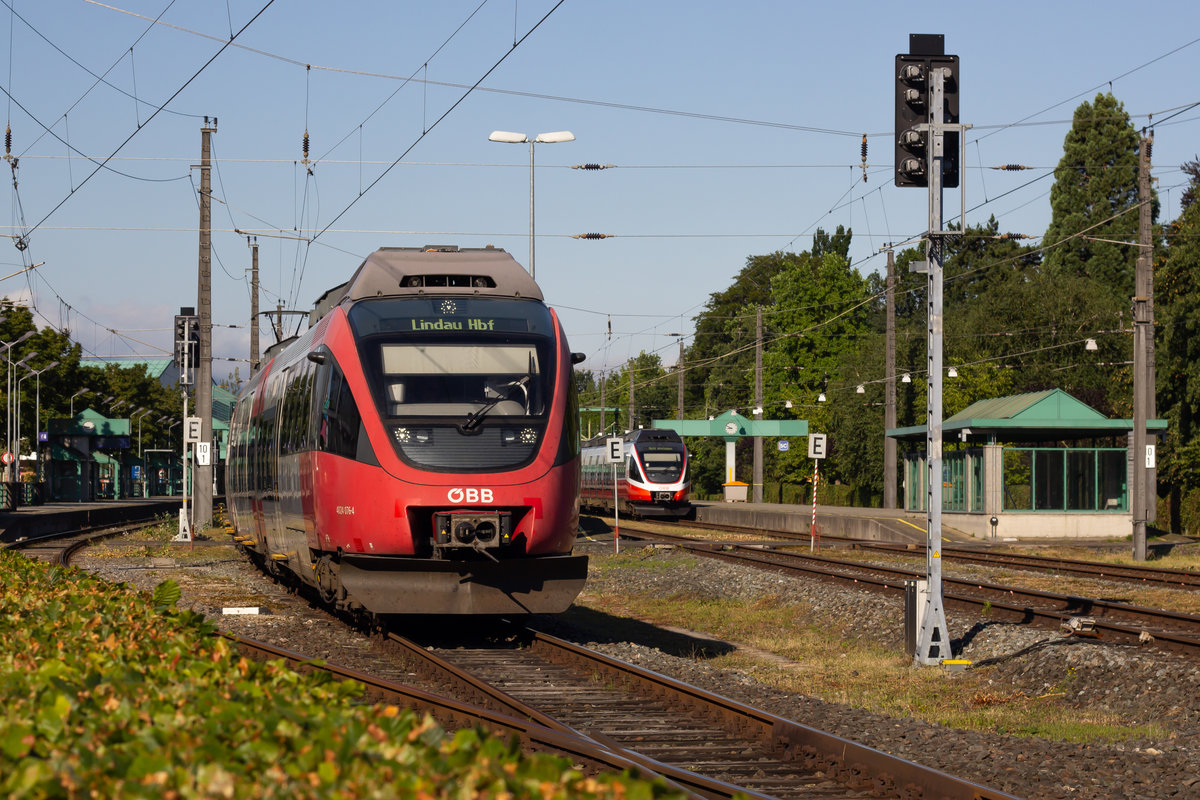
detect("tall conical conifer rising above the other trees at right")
[1043,94,1139,300]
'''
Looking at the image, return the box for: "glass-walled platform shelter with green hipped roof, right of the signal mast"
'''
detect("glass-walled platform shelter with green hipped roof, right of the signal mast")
[887,389,1166,539]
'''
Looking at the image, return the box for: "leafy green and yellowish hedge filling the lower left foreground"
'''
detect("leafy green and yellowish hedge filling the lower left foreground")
[0,551,686,799]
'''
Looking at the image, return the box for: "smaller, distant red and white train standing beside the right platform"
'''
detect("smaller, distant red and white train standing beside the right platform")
[581,428,692,518]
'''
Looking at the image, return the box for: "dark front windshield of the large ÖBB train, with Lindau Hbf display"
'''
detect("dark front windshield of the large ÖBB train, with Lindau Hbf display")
[348,297,556,471]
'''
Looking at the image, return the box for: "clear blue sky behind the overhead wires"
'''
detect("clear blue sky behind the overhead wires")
[0,0,1200,383]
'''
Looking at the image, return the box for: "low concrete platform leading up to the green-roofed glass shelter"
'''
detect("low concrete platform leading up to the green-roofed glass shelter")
[692,501,979,545]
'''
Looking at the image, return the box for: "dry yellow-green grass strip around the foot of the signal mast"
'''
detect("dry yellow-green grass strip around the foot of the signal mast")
[576,551,1168,744]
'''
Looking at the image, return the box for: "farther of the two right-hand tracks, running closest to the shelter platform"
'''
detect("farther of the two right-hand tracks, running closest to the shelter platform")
[648,521,1200,589]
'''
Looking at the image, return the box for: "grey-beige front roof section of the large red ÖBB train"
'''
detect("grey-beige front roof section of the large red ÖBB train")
[308,245,542,325]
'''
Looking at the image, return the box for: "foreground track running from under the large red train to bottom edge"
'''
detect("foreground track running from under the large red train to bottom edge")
[379,627,1009,800]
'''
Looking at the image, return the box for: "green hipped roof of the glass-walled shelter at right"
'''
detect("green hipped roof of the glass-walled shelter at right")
[887,389,1166,441]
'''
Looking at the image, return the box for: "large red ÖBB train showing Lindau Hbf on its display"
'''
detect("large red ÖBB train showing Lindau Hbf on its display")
[227,247,588,615]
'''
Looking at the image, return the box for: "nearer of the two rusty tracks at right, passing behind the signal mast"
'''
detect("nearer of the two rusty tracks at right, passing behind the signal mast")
[622,524,1200,657]
